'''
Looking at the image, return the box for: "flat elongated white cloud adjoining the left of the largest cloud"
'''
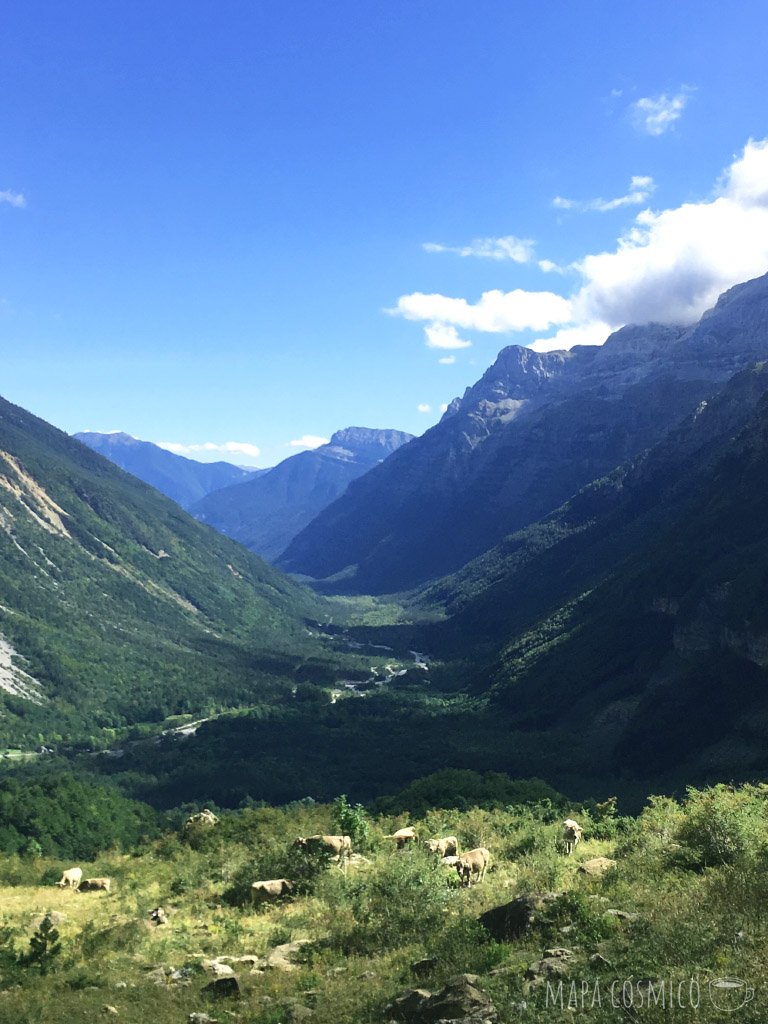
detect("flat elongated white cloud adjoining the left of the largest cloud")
[397,288,570,333]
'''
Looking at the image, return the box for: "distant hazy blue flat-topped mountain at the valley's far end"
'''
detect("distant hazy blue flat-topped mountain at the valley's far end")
[189,427,413,559]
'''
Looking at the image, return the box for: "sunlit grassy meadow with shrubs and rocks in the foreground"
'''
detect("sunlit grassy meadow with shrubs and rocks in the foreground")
[0,785,768,1024]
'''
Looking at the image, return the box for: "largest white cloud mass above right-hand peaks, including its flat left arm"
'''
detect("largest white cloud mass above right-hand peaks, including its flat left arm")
[389,139,768,351]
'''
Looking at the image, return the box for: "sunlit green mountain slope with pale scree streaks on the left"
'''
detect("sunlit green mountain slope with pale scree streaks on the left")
[0,399,335,742]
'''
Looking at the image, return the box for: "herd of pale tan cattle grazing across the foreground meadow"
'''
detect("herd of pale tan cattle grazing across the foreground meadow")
[56,809,584,904]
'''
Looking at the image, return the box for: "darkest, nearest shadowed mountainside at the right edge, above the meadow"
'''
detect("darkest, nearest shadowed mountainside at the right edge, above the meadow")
[478,367,768,777]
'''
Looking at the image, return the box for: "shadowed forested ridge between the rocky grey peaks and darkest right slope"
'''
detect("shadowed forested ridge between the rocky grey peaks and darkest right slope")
[419,362,768,651]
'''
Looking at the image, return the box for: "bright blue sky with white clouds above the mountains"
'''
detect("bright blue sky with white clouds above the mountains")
[0,0,768,465]
